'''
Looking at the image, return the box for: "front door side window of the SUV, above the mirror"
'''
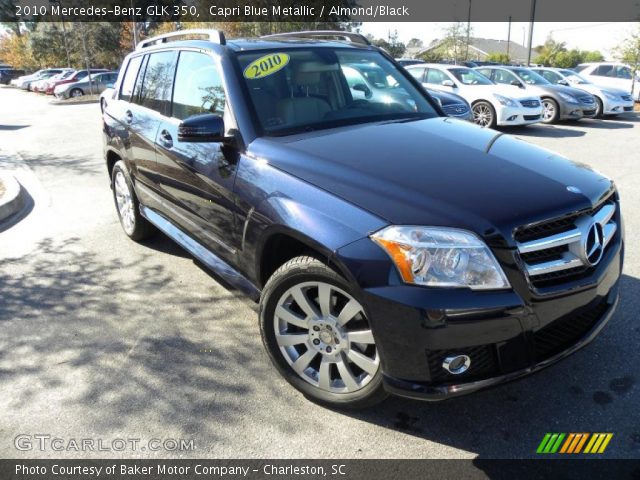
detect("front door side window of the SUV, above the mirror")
[172,52,225,119]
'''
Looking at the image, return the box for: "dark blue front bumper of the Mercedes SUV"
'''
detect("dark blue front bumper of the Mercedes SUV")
[339,229,623,400]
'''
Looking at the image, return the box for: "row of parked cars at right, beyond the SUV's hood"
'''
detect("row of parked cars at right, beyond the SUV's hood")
[388,63,634,127]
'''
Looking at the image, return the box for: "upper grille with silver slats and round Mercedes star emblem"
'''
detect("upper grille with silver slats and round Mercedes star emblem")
[514,192,618,288]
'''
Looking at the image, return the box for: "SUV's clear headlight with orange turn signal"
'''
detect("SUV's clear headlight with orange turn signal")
[371,225,509,290]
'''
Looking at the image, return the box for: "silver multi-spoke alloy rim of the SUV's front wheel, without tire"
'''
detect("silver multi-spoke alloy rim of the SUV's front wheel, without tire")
[274,281,380,393]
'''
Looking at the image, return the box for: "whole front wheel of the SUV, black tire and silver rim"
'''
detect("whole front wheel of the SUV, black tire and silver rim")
[260,256,387,409]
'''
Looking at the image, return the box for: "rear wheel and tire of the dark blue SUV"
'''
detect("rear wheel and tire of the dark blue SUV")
[111,160,155,242]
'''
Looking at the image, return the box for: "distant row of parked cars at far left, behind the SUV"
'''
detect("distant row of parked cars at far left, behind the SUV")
[10,68,118,100]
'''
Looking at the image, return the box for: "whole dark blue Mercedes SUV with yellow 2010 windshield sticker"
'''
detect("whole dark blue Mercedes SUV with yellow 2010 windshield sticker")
[103,30,624,407]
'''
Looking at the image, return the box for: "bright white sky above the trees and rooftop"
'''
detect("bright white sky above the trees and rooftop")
[360,22,638,60]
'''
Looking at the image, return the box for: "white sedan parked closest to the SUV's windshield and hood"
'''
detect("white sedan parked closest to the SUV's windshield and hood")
[406,63,542,127]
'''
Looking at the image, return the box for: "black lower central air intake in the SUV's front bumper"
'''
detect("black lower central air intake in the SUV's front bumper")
[533,299,609,362]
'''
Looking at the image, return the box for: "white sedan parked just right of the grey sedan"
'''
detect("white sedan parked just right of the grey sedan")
[531,67,633,117]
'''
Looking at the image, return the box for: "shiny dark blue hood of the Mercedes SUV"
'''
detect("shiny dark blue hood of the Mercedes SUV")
[248,117,612,246]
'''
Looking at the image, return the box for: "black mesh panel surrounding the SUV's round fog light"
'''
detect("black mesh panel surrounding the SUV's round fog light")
[427,345,498,382]
